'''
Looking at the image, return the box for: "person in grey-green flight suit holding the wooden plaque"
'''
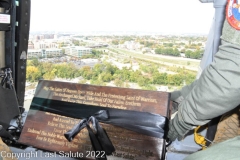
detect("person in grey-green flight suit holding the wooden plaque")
[168,1,240,160]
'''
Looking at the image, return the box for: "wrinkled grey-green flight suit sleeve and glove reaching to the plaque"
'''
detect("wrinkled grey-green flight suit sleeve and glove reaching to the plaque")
[168,21,240,140]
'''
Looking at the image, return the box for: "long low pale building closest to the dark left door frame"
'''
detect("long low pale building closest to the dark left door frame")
[27,48,63,58]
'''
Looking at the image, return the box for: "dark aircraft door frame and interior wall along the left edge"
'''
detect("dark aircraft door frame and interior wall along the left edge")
[0,0,30,138]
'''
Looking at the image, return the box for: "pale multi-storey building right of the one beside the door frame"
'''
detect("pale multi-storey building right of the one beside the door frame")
[63,46,92,58]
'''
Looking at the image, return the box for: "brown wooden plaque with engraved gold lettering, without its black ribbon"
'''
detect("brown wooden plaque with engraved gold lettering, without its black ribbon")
[19,81,170,160]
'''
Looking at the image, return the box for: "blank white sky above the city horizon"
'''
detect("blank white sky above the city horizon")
[30,0,214,34]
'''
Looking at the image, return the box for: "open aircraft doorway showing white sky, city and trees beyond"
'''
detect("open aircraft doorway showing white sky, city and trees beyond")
[25,0,214,109]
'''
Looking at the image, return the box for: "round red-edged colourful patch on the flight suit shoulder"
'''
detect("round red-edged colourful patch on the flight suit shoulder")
[226,0,240,30]
